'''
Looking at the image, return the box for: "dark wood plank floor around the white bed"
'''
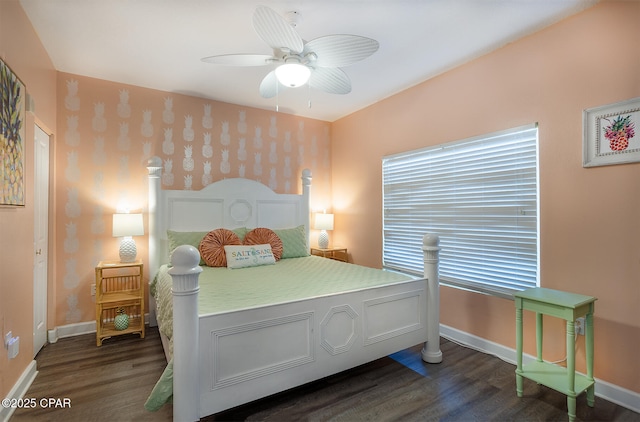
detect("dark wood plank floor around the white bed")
[11,328,640,422]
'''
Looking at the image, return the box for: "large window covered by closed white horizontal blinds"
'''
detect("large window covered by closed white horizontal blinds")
[382,124,538,297]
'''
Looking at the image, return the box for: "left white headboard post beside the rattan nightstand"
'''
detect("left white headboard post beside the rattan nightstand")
[147,157,162,327]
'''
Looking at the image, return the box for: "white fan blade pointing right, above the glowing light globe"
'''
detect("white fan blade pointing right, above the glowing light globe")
[303,34,380,67]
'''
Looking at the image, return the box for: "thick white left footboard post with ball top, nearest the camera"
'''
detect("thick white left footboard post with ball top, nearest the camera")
[169,245,202,422]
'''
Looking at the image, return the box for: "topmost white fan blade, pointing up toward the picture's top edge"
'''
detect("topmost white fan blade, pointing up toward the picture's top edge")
[253,6,304,54]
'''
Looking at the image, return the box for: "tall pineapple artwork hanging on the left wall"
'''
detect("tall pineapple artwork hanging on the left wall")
[0,59,26,206]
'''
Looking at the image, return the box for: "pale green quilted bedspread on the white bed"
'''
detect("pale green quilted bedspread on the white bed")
[145,256,411,410]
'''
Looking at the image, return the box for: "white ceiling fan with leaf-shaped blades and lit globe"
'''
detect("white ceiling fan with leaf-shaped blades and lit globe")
[202,6,379,98]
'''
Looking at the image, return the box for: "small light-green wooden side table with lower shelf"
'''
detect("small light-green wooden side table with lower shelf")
[513,287,596,421]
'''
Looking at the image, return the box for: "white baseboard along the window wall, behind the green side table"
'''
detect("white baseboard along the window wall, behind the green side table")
[440,324,640,413]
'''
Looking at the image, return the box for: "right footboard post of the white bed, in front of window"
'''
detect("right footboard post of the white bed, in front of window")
[422,233,442,363]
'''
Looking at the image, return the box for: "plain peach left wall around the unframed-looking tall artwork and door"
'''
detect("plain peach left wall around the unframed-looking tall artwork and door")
[0,0,56,402]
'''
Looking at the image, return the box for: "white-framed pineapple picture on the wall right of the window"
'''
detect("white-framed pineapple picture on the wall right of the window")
[582,97,640,167]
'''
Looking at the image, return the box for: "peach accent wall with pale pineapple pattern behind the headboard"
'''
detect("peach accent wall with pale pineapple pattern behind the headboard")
[53,73,331,325]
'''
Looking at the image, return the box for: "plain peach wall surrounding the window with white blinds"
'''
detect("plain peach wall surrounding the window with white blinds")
[332,1,640,393]
